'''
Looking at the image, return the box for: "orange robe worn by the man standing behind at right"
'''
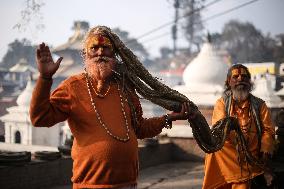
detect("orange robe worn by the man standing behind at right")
[203,98,275,189]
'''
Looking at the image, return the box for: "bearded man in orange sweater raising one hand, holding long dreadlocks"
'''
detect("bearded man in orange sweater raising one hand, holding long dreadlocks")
[30,26,193,189]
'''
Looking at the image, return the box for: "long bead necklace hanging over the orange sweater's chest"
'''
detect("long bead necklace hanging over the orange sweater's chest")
[85,73,130,142]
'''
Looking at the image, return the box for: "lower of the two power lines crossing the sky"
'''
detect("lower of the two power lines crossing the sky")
[141,0,259,43]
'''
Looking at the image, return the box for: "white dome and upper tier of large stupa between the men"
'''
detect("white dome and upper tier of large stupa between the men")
[175,39,229,106]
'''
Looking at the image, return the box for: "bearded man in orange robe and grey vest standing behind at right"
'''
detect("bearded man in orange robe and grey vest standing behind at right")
[203,64,275,189]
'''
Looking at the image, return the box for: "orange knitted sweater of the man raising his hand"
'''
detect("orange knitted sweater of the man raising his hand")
[30,74,165,188]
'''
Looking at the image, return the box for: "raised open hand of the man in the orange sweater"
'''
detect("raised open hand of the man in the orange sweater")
[36,43,63,79]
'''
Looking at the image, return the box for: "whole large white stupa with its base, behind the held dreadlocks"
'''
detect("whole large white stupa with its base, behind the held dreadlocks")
[162,40,229,139]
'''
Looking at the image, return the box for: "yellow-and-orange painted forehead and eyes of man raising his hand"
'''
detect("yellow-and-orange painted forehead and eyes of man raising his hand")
[85,34,113,53]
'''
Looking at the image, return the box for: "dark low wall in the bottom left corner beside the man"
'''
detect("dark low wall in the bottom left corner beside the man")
[0,158,72,189]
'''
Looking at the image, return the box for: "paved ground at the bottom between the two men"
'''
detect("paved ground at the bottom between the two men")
[51,162,204,189]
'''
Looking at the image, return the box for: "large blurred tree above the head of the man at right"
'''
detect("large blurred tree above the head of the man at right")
[204,20,284,63]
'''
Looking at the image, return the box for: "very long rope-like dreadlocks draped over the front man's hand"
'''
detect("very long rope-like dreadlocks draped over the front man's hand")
[80,26,251,156]
